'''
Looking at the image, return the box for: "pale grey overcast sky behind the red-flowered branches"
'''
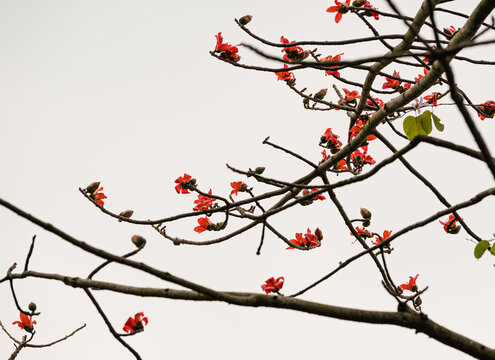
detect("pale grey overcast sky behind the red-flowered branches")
[0,0,495,360]
